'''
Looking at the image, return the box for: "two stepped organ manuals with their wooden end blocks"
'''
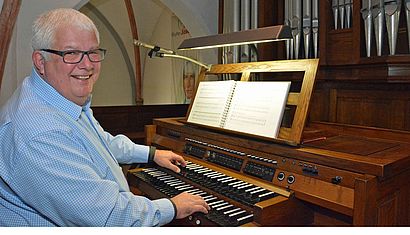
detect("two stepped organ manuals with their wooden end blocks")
[128,153,310,226]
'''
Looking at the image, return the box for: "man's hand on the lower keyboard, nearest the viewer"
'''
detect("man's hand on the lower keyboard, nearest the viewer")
[171,192,211,219]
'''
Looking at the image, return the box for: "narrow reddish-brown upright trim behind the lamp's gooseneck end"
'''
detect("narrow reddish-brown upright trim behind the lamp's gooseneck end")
[124,0,144,105]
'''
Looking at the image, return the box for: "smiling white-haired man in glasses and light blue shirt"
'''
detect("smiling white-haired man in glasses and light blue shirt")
[0,9,209,226]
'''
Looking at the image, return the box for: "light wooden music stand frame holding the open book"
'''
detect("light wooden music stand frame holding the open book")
[186,59,319,145]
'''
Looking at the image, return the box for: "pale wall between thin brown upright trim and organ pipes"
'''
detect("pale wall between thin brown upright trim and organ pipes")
[141,0,218,104]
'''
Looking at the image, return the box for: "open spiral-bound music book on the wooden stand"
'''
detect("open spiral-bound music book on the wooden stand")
[187,80,290,138]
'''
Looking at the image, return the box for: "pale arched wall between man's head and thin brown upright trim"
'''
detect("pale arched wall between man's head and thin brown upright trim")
[80,0,135,106]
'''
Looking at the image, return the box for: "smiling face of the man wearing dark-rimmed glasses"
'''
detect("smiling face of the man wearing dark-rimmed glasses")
[37,27,101,106]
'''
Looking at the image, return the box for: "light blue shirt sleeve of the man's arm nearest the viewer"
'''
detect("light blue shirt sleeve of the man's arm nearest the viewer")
[12,131,175,226]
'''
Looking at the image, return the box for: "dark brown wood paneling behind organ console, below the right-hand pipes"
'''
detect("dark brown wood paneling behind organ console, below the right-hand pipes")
[310,83,410,131]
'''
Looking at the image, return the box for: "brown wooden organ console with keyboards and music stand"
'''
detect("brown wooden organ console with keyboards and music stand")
[128,59,410,226]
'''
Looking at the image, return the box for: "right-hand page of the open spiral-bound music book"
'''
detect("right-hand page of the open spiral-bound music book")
[224,82,290,138]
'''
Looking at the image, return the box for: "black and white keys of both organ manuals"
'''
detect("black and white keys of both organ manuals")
[134,162,260,226]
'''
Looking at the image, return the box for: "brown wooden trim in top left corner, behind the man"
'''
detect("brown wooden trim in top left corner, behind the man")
[0,0,21,93]
